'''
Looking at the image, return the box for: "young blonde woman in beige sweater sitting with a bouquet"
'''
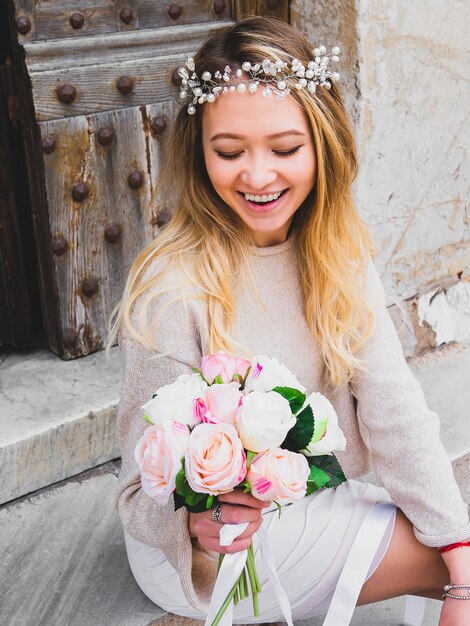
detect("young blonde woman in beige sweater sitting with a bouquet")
[111,18,470,626]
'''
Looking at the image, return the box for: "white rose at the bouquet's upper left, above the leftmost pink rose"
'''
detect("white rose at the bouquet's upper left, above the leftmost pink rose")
[142,374,207,426]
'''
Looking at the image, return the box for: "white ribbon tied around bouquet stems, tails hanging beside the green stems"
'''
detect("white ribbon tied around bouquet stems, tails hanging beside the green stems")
[205,522,294,626]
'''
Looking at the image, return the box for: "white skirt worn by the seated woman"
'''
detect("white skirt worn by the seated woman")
[124,480,396,626]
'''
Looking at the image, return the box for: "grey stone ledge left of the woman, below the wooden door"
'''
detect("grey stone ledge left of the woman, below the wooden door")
[0,349,120,503]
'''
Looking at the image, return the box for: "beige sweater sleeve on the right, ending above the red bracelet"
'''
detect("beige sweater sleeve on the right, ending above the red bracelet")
[351,262,470,547]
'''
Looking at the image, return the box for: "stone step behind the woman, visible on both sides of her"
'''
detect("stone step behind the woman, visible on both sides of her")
[0,344,470,503]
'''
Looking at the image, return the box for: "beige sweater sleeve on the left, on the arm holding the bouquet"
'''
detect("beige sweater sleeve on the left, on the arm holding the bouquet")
[115,280,216,610]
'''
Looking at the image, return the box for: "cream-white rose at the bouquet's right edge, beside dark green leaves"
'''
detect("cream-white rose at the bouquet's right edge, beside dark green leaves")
[301,393,346,456]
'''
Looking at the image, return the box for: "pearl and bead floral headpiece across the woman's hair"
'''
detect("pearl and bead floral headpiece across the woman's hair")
[174,46,340,115]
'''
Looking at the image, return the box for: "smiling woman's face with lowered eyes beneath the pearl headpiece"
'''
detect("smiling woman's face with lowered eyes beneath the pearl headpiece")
[202,91,316,247]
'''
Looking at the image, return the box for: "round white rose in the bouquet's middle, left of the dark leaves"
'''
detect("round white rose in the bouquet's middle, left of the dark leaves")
[237,391,296,452]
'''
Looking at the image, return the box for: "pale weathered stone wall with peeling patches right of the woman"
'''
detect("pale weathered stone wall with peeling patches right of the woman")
[291,0,470,354]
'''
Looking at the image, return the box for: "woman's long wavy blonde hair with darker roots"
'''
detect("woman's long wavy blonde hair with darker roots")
[108,17,374,385]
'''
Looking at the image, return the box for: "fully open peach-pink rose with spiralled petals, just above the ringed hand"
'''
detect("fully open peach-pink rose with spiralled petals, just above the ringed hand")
[185,424,246,496]
